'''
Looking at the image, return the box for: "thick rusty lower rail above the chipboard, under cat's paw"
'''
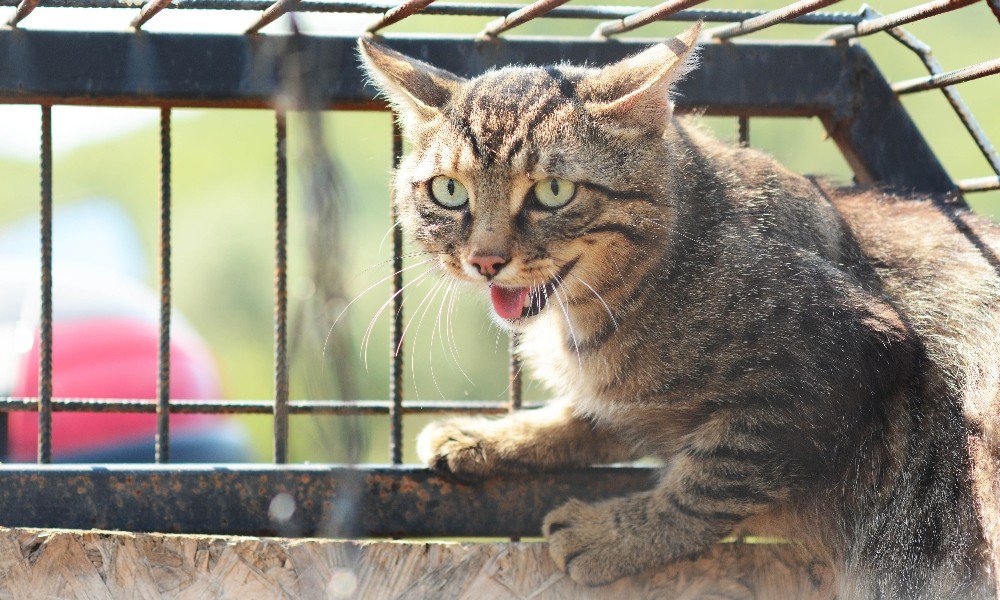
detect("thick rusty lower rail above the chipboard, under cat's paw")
[0,465,656,537]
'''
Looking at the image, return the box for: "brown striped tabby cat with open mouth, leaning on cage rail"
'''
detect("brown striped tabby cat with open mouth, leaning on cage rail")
[359,25,1000,598]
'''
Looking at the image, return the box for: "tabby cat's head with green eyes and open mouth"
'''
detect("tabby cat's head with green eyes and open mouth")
[360,25,700,325]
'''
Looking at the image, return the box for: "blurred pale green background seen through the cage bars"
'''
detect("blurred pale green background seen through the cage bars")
[0,0,1000,462]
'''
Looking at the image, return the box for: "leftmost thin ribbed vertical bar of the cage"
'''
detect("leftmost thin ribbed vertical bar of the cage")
[38,105,52,463]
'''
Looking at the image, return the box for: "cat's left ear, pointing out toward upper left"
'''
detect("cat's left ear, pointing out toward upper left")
[358,37,465,128]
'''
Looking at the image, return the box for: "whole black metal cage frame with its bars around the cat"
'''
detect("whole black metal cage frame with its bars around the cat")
[0,0,995,536]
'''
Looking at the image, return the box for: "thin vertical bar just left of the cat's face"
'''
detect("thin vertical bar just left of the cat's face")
[389,118,403,465]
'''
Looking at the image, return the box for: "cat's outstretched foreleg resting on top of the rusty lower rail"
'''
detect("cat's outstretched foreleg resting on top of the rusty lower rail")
[417,401,633,481]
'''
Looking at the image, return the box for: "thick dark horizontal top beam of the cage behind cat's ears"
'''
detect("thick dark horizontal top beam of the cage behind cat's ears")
[0,30,849,115]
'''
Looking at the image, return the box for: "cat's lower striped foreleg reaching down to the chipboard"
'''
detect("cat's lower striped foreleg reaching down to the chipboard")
[543,445,788,585]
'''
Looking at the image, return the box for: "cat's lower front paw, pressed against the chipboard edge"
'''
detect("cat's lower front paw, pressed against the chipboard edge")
[542,500,641,586]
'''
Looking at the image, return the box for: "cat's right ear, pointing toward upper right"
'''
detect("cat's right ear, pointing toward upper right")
[577,22,701,134]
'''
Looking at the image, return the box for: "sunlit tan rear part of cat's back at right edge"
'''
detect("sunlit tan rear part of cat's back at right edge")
[830,190,1000,444]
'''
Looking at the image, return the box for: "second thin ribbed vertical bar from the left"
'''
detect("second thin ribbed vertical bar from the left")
[156,106,171,463]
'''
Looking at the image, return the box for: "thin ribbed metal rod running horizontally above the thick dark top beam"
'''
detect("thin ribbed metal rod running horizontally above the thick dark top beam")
[0,0,861,25]
